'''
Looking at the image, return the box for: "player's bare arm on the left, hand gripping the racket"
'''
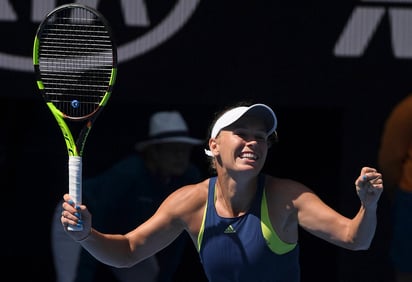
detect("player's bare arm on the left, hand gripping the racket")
[61,182,205,267]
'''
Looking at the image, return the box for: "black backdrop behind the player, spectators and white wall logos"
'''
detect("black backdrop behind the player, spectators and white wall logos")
[0,0,406,282]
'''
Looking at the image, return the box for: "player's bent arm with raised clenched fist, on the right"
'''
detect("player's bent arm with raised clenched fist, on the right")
[296,167,383,250]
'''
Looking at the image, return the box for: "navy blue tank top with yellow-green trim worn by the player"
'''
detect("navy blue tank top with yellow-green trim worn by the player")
[199,175,300,282]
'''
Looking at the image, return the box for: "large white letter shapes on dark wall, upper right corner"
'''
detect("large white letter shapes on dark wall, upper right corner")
[333,0,412,59]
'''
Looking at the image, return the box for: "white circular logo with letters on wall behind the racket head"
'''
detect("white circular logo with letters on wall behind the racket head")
[0,0,200,72]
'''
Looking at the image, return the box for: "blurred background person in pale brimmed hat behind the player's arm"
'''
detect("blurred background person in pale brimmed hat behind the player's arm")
[51,111,203,282]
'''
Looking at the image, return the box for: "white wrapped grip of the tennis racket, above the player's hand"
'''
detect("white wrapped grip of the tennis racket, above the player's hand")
[68,156,83,231]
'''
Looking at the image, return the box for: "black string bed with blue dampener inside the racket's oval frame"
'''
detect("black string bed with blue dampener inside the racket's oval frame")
[39,6,114,118]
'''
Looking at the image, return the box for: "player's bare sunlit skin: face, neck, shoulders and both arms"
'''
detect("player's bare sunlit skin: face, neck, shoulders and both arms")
[61,109,383,267]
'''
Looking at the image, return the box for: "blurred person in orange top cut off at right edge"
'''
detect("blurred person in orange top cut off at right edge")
[378,94,412,282]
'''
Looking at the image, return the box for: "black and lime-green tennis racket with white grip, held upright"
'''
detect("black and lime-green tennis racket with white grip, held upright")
[33,4,117,231]
